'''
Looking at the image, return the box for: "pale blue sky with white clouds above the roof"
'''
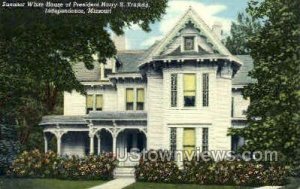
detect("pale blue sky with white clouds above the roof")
[125,0,247,50]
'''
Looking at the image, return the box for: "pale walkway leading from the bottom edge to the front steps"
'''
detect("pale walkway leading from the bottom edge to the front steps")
[89,178,135,189]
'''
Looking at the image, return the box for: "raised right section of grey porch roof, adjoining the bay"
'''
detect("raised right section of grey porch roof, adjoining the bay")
[85,111,147,120]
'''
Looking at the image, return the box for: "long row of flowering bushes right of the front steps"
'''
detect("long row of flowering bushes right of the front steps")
[135,151,288,186]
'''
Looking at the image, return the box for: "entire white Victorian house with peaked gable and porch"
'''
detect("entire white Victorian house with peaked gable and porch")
[40,8,252,161]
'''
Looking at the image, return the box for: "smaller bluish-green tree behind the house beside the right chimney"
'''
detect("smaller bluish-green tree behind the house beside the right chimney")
[225,13,261,55]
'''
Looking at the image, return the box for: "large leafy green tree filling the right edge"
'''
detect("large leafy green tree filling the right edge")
[231,0,300,162]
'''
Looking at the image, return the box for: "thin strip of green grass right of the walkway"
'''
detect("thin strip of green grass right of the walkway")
[125,182,250,189]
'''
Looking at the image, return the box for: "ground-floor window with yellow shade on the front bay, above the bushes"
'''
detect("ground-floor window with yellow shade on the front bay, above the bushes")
[183,128,196,157]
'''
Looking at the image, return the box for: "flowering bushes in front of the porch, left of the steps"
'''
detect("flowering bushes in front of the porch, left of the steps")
[7,150,118,180]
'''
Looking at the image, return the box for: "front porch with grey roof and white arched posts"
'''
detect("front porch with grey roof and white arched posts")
[40,111,147,158]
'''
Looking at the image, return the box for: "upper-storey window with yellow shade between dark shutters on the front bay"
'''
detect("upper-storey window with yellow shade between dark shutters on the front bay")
[183,74,196,107]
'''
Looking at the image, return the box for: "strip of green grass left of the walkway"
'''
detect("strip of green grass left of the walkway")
[0,178,105,189]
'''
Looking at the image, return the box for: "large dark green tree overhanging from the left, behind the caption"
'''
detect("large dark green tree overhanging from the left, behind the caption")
[0,0,167,148]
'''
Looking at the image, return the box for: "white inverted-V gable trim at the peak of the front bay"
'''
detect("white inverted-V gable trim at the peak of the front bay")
[139,7,242,66]
